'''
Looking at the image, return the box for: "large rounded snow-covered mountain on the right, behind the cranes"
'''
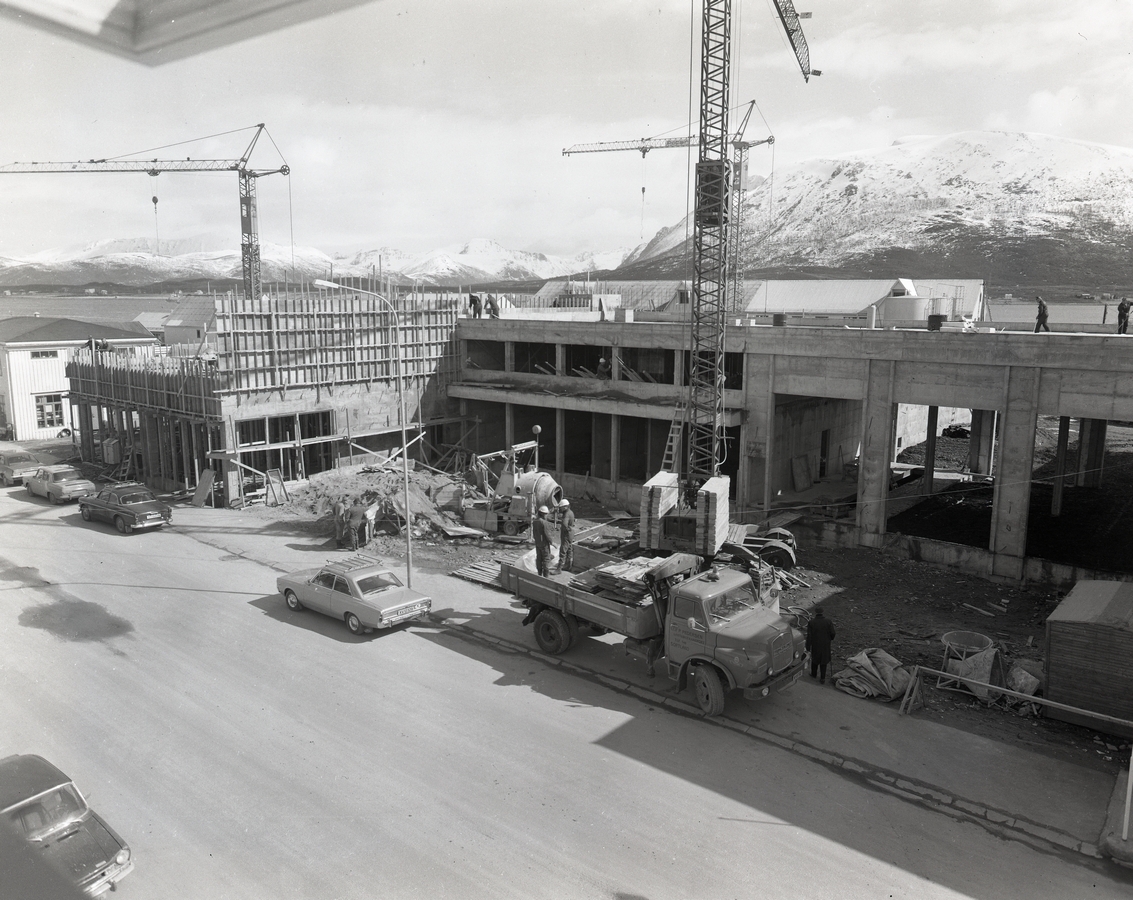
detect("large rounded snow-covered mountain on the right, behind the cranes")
[623,131,1133,283]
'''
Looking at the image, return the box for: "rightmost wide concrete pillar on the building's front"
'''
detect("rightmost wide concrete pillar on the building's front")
[989,366,1041,579]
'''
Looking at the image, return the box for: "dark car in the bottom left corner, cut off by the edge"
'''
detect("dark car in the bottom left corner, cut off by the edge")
[0,754,134,897]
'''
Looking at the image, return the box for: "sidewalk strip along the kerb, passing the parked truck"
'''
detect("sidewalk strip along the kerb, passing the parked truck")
[164,504,1133,864]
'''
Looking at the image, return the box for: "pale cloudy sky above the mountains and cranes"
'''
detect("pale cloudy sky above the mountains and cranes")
[0,0,1133,256]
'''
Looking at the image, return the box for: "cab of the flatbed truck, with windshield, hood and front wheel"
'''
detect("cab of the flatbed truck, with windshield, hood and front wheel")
[665,566,806,715]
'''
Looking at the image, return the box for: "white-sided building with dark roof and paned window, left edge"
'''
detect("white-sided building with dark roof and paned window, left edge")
[0,316,157,441]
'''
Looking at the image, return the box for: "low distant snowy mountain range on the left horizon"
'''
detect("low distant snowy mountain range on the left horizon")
[0,236,627,286]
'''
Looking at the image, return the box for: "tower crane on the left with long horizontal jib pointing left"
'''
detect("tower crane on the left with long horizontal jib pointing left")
[0,122,291,298]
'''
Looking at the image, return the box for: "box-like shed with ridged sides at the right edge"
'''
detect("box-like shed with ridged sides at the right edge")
[1046,581,1133,737]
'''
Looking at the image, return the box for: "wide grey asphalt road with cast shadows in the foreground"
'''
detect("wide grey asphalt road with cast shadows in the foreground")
[0,489,1130,900]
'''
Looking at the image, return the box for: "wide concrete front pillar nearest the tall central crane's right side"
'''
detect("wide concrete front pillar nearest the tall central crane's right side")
[858,359,895,546]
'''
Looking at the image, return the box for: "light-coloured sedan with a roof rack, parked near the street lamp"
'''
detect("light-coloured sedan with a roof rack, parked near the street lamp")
[275,553,433,635]
